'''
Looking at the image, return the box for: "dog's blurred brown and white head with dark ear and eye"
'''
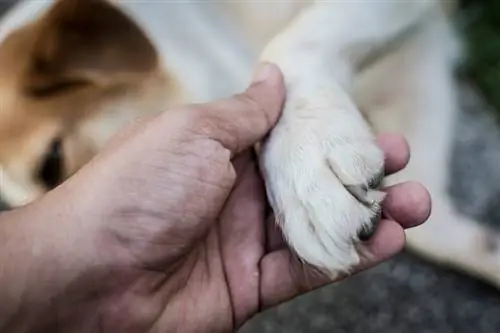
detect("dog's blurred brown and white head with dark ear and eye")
[0,0,176,206]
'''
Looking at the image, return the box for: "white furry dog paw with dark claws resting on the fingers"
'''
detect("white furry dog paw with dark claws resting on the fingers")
[260,95,384,277]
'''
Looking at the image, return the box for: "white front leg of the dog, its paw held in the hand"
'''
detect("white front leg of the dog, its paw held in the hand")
[260,1,438,277]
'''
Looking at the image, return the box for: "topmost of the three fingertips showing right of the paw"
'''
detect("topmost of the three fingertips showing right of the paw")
[378,134,410,175]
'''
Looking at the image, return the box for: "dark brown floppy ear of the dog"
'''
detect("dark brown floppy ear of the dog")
[26,0,157,95]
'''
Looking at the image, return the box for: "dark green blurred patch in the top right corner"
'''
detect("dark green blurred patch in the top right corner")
[461,0,500,115]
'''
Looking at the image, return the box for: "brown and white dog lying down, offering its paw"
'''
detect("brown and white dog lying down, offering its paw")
[0,0,500,287]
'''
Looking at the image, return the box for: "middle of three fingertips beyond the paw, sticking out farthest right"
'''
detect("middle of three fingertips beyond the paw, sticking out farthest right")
[383,182,432,228]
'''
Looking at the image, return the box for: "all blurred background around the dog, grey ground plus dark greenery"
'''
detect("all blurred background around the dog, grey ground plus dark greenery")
[0,0,500,333]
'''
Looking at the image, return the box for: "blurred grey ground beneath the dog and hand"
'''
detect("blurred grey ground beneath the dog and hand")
[0,0,500,333]
